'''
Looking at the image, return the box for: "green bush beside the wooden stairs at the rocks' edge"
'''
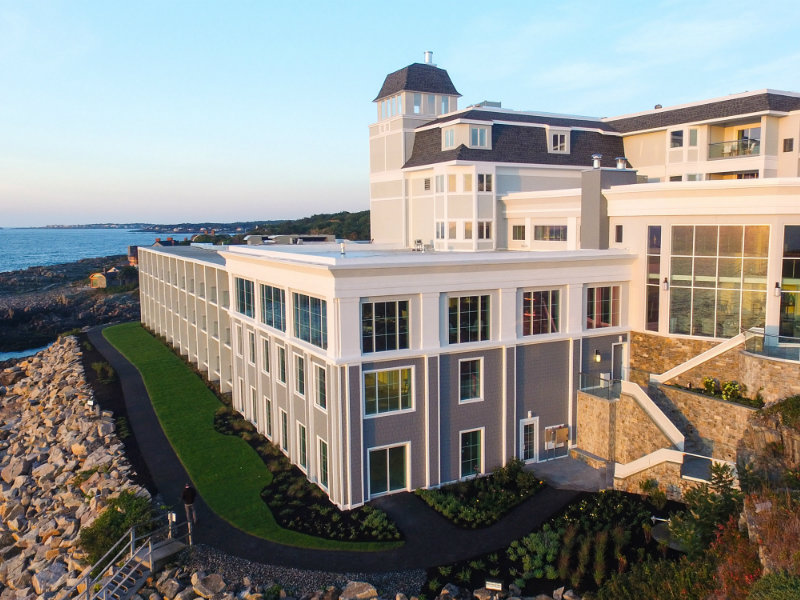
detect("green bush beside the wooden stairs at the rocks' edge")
[78,491,153,564]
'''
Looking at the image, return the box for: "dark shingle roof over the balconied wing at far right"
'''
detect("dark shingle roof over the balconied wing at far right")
[604,93,800,133]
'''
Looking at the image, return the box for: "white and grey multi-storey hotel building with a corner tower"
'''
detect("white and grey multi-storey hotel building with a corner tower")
[139,56,800,508]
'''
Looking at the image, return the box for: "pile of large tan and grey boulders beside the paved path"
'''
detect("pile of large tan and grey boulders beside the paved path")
[0,337,148,600]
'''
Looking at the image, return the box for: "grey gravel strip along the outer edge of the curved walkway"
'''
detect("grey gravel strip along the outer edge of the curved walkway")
[186,544,425,598]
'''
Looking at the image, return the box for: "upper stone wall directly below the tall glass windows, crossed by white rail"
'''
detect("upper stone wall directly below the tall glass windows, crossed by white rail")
[630,332,800,404]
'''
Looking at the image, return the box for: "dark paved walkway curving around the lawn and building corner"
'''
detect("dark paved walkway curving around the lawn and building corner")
[89,328,579,572]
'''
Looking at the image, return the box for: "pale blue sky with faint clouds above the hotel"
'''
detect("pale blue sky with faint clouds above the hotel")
[0,0,800,227]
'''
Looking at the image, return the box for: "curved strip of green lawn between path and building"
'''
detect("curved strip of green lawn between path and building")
[103,323,402,551]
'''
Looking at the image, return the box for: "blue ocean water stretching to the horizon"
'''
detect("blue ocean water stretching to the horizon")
[0,229,192,272]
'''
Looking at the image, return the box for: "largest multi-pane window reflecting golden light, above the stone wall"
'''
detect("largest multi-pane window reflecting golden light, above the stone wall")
[668,225,769,338]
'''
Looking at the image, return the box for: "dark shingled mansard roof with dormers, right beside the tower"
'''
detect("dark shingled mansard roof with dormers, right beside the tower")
[403,124,624,167]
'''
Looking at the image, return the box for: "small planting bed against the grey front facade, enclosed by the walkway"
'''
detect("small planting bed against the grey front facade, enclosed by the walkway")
[416,459,544,529]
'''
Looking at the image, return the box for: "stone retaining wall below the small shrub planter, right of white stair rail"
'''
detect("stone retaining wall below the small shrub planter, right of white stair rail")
[658,386,756,462]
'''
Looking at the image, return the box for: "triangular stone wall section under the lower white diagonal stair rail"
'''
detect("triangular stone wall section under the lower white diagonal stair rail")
[614,394,672,464]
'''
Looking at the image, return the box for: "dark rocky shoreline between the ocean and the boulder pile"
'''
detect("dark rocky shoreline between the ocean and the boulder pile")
[0,255,139,352]
